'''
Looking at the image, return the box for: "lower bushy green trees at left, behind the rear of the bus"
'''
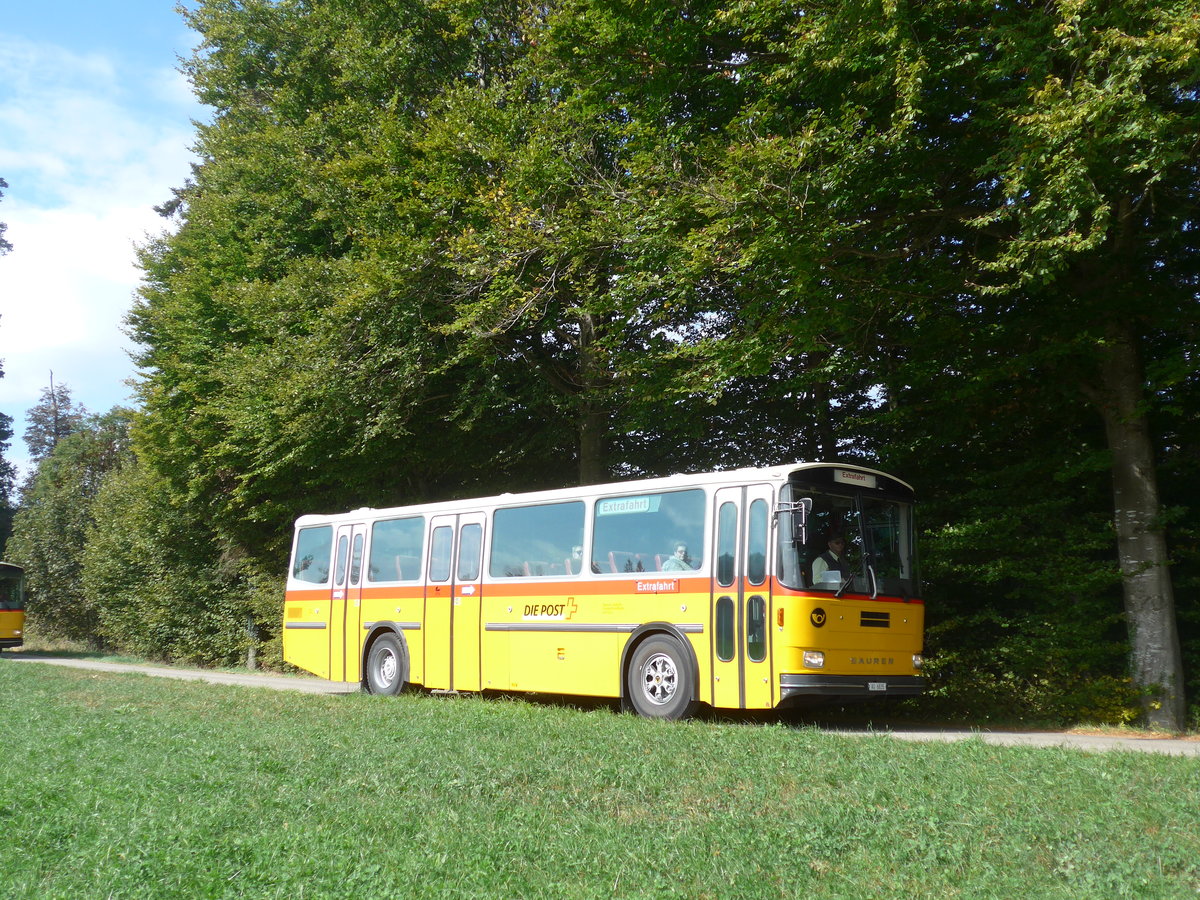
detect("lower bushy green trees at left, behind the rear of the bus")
[10,398,282,666]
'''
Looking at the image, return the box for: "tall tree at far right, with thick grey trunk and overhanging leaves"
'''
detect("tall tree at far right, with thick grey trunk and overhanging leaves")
[662,2,1200,728]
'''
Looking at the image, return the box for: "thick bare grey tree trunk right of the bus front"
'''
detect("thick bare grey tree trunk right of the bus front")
[1091,323,1184,731]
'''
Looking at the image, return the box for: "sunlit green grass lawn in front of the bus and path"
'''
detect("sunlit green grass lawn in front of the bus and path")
[0,658,1200,900]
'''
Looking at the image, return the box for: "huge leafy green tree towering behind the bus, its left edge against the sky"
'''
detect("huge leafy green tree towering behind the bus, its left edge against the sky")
[131,2,777,534]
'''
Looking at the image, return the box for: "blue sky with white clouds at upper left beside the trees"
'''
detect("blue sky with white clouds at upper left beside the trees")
[0,0,206,475]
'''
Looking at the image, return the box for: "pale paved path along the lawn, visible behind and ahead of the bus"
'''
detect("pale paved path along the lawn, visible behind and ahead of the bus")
[4,653,1200,756]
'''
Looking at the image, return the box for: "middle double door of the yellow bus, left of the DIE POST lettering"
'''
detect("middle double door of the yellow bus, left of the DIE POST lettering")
[422,512,485,690]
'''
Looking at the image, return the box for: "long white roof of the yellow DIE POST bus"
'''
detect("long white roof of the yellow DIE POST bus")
[295,462,912,528]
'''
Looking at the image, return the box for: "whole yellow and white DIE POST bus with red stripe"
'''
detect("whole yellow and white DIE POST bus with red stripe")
[283,463,924,719]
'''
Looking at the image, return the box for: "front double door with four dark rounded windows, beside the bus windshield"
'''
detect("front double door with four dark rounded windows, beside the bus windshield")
[709,485,775,709]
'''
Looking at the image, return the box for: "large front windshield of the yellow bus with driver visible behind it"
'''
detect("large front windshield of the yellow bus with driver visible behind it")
[779,481,919,598]
